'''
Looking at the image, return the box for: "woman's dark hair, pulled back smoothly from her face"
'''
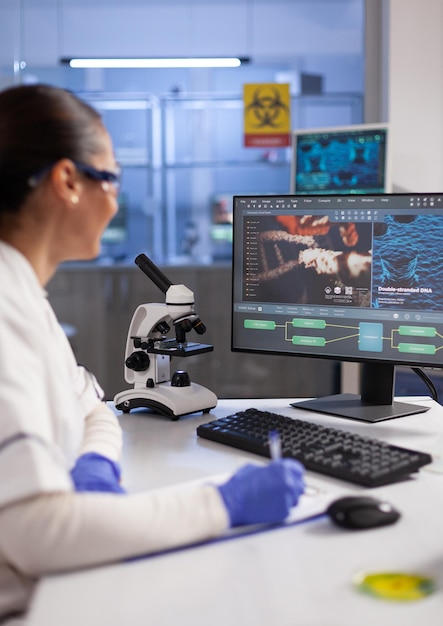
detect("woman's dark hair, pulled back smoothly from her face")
[0,84,103,214]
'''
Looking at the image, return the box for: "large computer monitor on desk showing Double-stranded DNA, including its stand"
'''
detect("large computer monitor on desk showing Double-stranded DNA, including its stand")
[231,193,443,422]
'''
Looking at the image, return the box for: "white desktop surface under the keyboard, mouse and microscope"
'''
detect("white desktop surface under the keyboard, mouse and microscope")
[29,398,443,626]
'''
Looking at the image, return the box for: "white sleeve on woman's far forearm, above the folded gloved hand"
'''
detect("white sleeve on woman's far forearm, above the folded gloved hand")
[79,402,122,461]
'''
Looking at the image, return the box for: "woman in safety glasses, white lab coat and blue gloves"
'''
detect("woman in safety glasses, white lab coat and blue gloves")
[0,85,304,624]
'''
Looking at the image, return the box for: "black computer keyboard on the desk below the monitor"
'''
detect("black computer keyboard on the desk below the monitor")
[197,408,432,487]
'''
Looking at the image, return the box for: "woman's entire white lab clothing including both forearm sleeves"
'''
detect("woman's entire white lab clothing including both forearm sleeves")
[0,241,228,621]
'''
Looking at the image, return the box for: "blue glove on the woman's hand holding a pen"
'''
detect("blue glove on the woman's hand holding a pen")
[218,459,305,526]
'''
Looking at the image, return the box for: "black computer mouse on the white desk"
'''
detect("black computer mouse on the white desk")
[326,496,400,530]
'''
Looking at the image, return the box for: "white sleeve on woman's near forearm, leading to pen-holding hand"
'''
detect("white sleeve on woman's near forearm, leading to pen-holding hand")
[0,485,228,577]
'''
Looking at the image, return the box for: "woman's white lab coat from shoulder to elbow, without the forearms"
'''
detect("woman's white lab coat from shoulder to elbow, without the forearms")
[0,242,102,506]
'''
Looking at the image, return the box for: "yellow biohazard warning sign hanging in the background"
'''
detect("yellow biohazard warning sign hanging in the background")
[243,83,291,148]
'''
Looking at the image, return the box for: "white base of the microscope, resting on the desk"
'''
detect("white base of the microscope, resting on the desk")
[114,382,217,420]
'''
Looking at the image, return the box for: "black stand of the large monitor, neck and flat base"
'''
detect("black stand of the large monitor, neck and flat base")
[291,363,429,422]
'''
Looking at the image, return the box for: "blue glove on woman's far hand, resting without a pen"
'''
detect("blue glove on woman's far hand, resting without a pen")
[71,452,126,493]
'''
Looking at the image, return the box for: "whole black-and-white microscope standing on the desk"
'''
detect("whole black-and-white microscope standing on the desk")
[114,254,217,420]
